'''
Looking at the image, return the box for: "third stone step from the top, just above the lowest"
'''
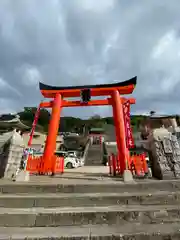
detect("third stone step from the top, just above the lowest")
[0,205,180,227]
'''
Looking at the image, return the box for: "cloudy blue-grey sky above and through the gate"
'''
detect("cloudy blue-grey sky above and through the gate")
[0,0,180,117]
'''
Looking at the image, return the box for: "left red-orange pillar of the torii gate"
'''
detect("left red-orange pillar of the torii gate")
[43,94,62,170]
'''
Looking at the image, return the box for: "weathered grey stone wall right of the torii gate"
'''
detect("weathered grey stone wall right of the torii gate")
[147,128,180,179]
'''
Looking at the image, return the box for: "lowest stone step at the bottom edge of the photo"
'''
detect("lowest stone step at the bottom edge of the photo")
[0,223,180,240]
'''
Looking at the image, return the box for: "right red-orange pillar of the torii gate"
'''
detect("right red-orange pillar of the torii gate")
[111,90,126,174]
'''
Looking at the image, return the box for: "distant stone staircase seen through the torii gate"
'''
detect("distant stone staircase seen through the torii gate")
[85,144,102,166]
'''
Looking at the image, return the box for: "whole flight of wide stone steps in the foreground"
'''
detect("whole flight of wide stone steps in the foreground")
[0,180,180,240]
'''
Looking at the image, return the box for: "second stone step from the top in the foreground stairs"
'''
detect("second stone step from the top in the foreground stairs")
[0,191,180,208]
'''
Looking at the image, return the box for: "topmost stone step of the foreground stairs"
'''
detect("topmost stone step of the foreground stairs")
[0,178,180,194]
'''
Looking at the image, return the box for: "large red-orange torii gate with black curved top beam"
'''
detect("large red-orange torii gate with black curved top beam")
[29,77,137,174]
